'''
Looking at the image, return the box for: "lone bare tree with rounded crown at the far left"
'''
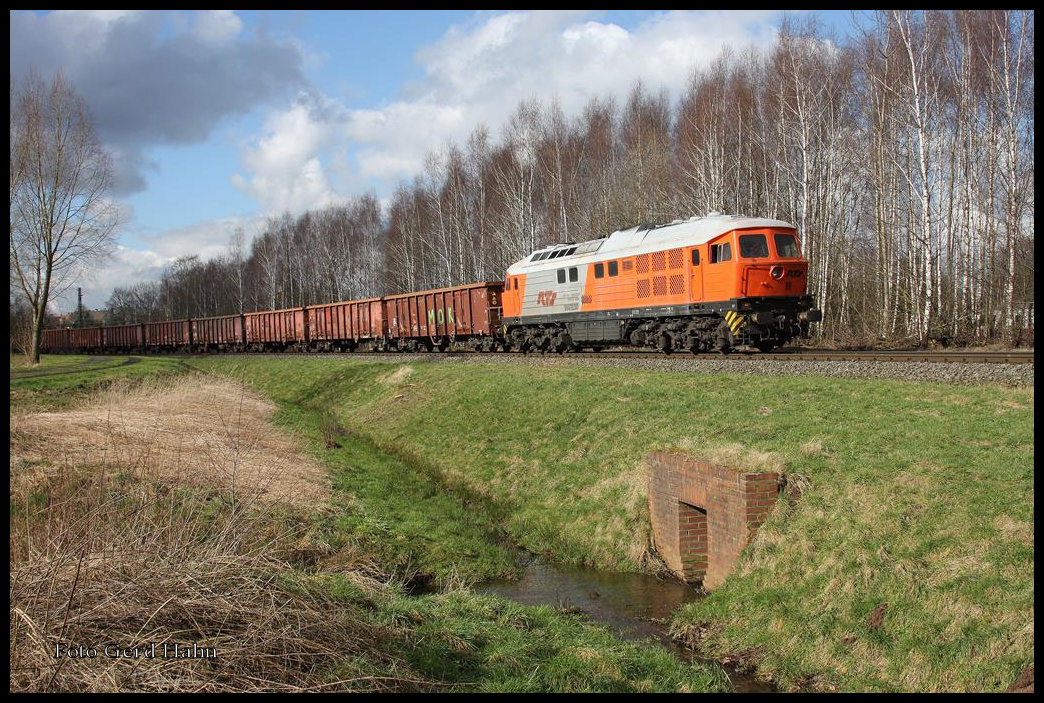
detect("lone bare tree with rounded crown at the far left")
[10,73,117,364]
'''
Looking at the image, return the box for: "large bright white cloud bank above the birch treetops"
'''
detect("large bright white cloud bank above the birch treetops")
[237,10,778,202]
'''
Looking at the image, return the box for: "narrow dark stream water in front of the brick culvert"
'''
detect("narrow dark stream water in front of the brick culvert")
[475,556,776,693]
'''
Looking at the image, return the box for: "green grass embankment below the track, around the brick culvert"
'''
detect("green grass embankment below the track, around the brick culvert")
[192,357,1034,690]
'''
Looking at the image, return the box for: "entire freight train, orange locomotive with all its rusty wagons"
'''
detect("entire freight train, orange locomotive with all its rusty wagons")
[43,213,823,353]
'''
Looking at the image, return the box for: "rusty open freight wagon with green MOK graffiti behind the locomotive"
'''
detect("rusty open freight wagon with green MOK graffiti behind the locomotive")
[383,281,504,351]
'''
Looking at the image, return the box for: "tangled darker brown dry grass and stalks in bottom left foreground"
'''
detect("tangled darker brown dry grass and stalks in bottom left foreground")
[10,471,428,692]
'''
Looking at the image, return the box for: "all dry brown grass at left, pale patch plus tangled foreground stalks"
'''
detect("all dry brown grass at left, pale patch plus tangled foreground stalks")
[10,379,433,692]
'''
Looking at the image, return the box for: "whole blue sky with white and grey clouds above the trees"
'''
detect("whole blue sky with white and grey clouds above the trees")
[10,10,852,310]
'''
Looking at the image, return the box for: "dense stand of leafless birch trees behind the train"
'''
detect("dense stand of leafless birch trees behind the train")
[99,10,1034,344]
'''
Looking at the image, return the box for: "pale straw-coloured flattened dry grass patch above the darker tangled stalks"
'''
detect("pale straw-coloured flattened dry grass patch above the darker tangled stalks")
[10,376,330,507]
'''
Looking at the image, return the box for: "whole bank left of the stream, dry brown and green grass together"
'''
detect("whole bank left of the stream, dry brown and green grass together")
[10,357,725,692]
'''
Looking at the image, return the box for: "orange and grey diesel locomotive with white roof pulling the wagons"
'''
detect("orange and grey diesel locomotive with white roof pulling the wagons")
[503,213,823,353]
